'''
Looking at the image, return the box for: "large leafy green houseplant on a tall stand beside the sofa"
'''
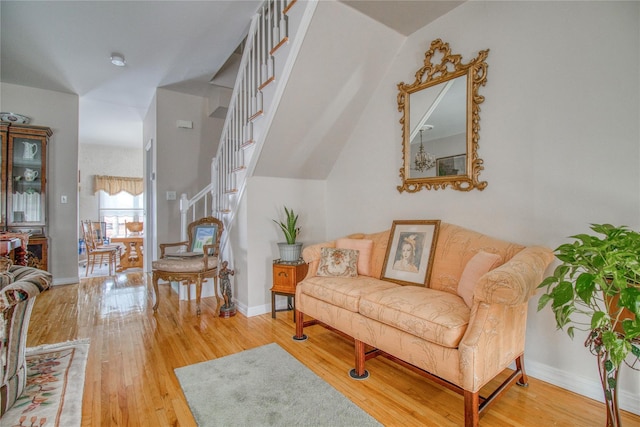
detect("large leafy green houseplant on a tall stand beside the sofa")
[538,224,640,427]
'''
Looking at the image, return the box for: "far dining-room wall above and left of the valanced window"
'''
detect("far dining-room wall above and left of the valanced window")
[78,144,143,221]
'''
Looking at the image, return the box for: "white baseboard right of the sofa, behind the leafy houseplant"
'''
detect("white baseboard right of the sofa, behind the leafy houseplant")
[525,359,640,415]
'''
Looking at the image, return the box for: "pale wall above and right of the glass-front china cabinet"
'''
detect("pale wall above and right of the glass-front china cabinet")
[0,83,78,285]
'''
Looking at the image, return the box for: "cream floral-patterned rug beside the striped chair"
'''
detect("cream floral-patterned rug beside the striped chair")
[0,339,89,427]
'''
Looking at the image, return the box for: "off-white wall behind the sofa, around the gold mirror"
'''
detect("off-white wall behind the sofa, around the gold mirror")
[328,2,640,413]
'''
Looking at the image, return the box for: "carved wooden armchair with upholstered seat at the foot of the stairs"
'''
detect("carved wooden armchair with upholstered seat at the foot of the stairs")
[152,217,224,314]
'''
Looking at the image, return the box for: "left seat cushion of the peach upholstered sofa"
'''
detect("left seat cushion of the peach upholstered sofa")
[296,276,400,313]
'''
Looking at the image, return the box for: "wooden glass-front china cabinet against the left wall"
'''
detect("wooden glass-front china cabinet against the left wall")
[2,123,52,270]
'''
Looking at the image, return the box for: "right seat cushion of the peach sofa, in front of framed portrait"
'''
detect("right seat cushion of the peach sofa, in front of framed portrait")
[360,286,471,348]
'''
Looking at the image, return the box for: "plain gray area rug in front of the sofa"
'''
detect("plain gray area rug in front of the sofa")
[175,343,381,427]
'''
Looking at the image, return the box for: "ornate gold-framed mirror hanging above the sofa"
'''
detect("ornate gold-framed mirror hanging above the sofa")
[398,39,489,193]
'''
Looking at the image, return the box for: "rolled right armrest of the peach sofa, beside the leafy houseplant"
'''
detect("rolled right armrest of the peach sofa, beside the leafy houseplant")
[474,246,554,306]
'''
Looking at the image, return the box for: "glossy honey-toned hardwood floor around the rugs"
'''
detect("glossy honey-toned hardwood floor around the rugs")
[28,273,640,427]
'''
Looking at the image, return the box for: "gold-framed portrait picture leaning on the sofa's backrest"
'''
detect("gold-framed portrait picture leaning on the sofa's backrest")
[382,220,440,286]
